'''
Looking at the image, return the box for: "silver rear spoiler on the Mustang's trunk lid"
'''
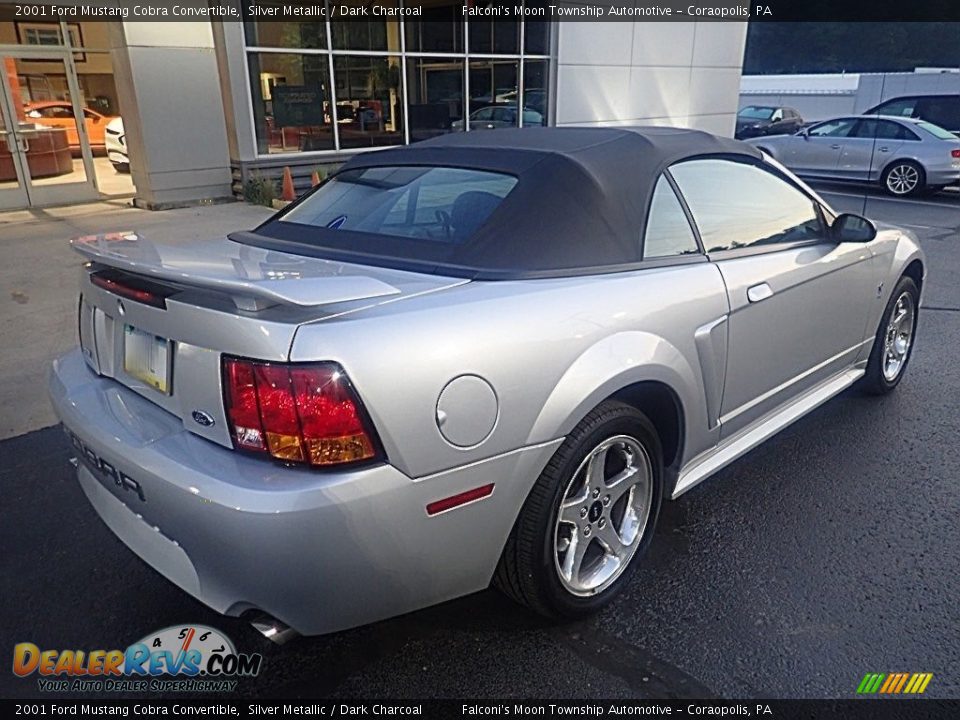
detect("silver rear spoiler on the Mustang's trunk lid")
[70,232,400,310]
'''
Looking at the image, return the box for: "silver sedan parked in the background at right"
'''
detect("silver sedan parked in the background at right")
[747,115,960,196]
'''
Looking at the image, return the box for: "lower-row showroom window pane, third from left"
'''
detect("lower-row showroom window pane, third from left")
[407,57,463,142]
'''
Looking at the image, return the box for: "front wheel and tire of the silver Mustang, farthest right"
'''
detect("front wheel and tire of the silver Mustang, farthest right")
[861,276,920,395]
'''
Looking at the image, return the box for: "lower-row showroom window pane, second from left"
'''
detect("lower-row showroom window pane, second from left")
[333,55,404,148]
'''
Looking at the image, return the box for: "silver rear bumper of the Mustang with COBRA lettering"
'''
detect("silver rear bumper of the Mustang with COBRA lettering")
[49,350,560,634]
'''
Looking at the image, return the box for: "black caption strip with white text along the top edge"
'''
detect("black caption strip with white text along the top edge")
[0,0,960,22]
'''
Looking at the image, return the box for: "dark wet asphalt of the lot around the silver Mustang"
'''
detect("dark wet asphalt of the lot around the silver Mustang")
[0,185,960,698]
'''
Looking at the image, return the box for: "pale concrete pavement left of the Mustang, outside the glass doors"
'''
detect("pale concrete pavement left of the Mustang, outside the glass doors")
[0,201,271,440]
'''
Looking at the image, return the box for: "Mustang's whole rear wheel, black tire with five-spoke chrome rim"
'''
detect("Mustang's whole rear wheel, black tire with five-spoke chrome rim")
[494,401,663,618]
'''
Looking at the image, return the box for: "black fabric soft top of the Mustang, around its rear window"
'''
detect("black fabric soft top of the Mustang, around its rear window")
[249,127,761,279]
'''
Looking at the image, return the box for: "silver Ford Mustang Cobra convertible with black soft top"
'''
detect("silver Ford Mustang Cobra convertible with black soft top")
[49,128,924,634]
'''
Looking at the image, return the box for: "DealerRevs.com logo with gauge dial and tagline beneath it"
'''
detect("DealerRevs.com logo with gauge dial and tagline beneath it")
[13,625,263,692]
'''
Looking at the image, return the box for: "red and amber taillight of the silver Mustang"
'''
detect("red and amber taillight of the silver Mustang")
[223,357,378,466]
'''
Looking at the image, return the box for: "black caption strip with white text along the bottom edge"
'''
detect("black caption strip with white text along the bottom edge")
[0,698,960,720]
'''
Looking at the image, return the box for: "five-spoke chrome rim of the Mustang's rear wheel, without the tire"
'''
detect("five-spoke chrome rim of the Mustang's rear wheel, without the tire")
[553,435,653,597]
